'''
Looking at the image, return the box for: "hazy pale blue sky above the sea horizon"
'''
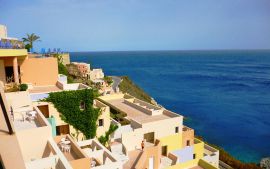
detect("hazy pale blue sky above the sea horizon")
[0,0,270,51]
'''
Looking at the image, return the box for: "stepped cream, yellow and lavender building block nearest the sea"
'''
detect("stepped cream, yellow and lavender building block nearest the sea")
[99,93,219,169]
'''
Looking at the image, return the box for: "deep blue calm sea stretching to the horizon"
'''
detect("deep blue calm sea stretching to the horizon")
[71,51,270,162]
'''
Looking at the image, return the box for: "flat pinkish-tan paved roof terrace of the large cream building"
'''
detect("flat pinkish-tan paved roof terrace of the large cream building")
[104,98,174,124]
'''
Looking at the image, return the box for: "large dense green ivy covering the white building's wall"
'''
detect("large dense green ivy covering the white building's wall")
[46,89,100,139]
